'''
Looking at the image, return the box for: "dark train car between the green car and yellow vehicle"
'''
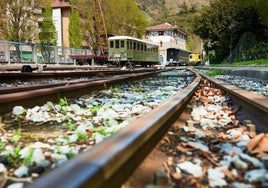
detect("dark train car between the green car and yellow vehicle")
[167,48,189,66]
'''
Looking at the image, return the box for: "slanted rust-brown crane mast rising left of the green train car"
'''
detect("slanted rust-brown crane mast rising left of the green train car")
[93,0,108,54]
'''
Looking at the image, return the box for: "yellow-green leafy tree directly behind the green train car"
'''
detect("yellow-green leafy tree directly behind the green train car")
[71,0,149,48]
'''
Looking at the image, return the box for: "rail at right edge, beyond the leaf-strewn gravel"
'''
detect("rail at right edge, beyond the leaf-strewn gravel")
[200,74,268,132]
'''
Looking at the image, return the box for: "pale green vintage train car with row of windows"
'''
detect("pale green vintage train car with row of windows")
[108,36,159,66]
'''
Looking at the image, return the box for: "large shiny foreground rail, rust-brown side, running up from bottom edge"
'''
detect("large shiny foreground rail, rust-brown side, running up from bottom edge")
[28,72,201,188]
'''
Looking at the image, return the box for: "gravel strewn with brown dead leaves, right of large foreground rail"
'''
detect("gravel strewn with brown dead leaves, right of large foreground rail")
[122,74,268,188]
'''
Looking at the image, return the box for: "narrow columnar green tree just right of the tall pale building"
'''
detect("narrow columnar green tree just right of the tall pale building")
[69,7,83,48]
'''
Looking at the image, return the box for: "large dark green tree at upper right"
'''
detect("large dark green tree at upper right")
[193,0,268,62]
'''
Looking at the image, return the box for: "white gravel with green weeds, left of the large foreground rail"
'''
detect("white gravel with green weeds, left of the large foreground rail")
[1,70,193,187]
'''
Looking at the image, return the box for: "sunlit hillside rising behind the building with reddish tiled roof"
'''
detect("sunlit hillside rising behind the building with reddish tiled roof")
[136,0,209,53]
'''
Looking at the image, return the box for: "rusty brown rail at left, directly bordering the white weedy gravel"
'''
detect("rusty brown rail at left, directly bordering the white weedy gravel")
[0,70,163,114]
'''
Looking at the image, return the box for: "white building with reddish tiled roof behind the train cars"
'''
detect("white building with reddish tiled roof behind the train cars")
[145,23,188,65]
